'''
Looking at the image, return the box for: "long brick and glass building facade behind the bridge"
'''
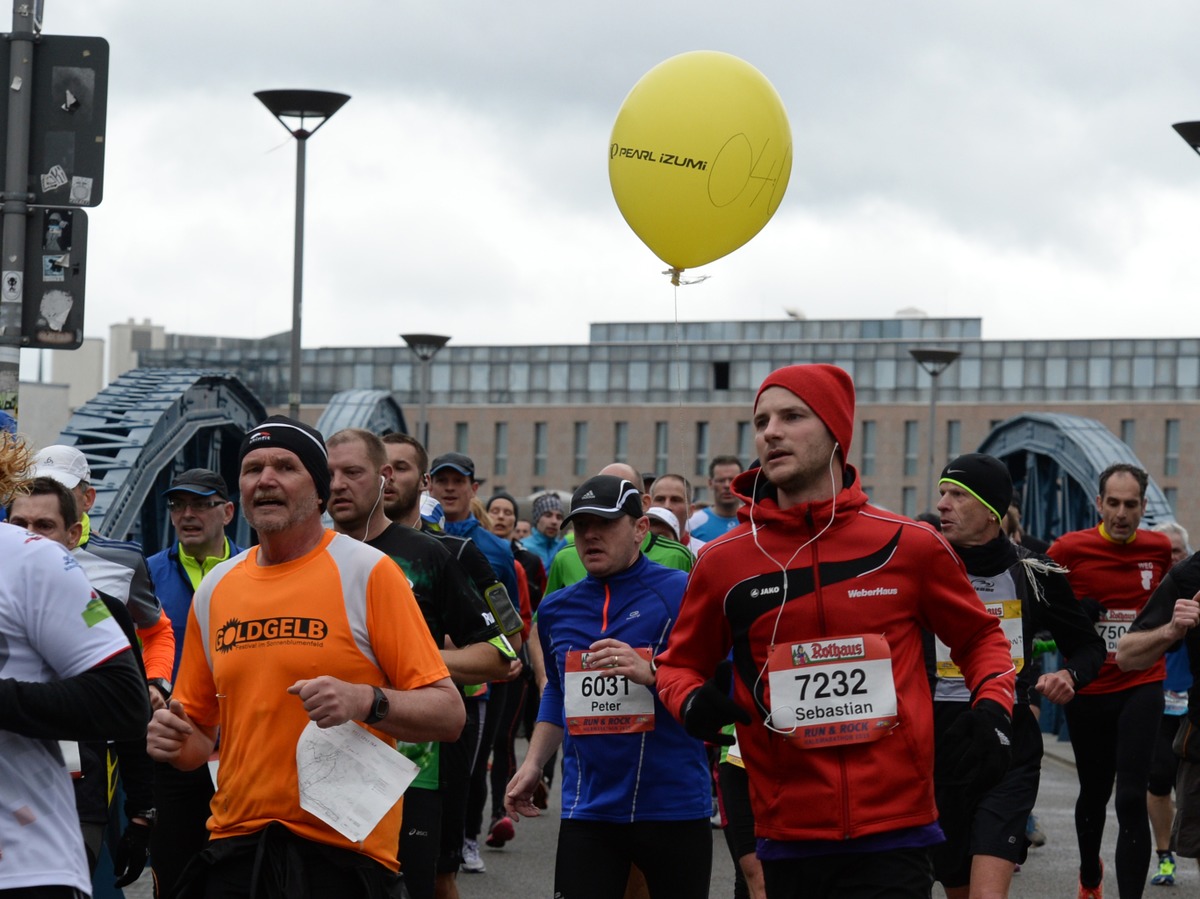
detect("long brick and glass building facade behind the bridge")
[138,317,1200,527]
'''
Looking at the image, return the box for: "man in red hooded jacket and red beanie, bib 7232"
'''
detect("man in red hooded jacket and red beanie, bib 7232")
[658,365,1015,899]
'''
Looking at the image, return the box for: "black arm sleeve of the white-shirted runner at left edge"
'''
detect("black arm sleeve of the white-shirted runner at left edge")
[0,649,150,741]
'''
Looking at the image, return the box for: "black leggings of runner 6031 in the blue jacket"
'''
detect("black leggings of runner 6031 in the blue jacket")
[554,817,713,899]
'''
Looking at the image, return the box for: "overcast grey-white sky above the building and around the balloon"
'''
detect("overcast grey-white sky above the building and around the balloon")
[25,0,1200,364]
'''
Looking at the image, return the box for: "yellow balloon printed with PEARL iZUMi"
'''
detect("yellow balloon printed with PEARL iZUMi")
[608,50,792,269]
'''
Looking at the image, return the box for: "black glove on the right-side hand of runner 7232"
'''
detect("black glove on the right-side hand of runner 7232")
[935,700,1013,796]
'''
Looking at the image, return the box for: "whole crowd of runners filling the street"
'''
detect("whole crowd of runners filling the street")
[0,365,1200,899]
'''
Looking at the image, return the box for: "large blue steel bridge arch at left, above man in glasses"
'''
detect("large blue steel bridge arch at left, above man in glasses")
[59,368,266,555]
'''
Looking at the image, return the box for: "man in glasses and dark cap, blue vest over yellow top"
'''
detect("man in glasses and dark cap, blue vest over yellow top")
[148,468,241,895]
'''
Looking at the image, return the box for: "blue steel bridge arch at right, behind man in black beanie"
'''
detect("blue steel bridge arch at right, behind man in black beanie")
[979,412,1175,540]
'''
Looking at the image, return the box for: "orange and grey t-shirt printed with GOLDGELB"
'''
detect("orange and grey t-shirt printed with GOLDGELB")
[175,531,449,870]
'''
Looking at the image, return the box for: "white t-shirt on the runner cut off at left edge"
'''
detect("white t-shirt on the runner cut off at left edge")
[0,525,130,894]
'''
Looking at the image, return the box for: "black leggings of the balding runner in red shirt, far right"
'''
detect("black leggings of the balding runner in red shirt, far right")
[1066,681,1163,899]
